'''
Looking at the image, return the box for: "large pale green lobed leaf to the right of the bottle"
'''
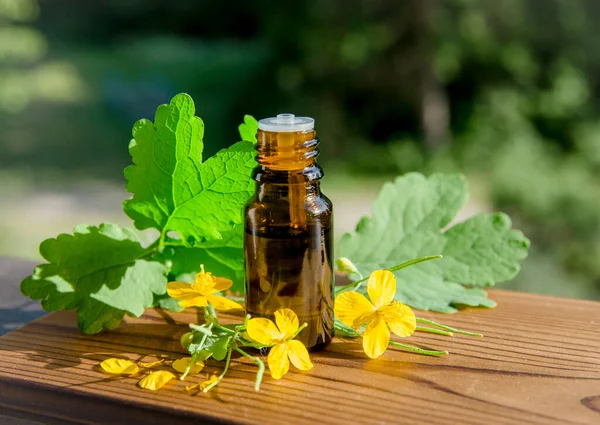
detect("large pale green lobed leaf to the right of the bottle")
[338,173,529,313]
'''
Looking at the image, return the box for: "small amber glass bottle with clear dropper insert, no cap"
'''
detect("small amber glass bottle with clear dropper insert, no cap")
[244,114,334,350]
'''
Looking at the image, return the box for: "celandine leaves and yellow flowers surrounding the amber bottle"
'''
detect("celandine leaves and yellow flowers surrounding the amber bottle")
[21,94,529,391]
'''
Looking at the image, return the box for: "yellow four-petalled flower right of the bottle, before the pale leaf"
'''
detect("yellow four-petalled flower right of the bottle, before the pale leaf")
[334,270,417,359]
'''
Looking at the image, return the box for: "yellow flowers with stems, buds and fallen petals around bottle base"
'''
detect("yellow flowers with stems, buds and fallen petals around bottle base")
[100,256,481,392]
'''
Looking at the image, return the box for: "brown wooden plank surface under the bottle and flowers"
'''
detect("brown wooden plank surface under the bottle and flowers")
[0,291,600,424]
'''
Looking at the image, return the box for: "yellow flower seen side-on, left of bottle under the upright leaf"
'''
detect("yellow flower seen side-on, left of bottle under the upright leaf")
[167,266,242,310]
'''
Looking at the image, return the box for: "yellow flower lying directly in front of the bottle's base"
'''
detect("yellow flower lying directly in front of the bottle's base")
[247,308,313,379]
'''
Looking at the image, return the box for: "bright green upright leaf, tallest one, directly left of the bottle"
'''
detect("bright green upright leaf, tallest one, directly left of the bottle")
[123,94,256,247]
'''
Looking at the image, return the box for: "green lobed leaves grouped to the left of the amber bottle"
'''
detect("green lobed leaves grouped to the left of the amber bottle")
[21,94,255,333]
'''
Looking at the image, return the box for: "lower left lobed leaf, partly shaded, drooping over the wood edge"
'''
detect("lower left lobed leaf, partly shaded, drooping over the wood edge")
[21,223,167,333]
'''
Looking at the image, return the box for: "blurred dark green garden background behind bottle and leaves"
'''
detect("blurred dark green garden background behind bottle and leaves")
[0,0,600,299]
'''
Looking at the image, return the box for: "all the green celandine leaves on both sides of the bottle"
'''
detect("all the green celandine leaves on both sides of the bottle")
[21,94,528,334]
